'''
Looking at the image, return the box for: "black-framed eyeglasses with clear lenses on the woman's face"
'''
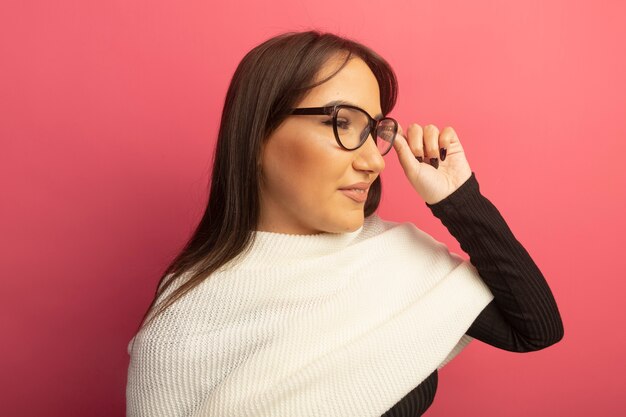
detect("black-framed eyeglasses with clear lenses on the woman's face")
[291,104,398,155]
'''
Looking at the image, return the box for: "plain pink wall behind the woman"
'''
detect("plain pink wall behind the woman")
[0,0,626,417]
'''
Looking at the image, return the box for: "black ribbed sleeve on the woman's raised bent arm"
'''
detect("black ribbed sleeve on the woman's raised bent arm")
[426,172,563,352]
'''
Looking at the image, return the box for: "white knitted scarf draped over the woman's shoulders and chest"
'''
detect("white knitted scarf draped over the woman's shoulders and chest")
[127,214,493,417]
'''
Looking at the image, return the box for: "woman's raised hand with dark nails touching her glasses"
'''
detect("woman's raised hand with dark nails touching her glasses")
[393,123,472,204]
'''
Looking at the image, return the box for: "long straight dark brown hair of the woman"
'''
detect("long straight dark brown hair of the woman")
[140,30,398,328]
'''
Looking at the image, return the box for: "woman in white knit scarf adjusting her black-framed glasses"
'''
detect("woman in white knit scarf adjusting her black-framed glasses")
[127,31,563,417]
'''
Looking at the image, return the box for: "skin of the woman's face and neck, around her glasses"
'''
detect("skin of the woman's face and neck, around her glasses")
[257,57,385,234]
